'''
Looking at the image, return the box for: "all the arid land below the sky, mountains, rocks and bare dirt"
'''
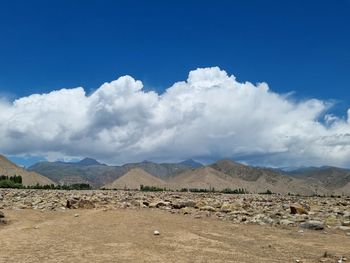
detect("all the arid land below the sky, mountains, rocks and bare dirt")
[0,156,350,263]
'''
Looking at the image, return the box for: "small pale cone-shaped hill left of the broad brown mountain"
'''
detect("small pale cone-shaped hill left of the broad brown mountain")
[103,168,166,189]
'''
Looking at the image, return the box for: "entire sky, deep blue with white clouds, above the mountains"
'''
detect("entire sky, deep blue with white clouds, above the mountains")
[0,0,350,167]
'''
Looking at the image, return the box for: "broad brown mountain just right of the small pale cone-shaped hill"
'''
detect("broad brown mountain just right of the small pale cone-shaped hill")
[168,160,328,195]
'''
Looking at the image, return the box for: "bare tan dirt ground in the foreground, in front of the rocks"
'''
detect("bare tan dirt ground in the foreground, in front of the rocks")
[0,209,350,263]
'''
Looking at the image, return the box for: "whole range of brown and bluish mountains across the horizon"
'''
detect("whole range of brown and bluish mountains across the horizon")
[0,156,350,195]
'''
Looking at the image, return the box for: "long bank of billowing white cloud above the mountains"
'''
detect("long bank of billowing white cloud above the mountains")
[0,67,350,167]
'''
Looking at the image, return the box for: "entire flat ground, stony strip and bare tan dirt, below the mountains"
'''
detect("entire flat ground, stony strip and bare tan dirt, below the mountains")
[0,189,350,262]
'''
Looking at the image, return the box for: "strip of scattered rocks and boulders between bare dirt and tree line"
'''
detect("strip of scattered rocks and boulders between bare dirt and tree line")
[0,190,350,232]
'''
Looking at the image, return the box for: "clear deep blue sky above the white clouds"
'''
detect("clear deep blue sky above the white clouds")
[0,0,350,165]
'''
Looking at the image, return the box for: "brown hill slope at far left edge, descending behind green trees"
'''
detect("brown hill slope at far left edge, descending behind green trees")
[0,155,55,186]
